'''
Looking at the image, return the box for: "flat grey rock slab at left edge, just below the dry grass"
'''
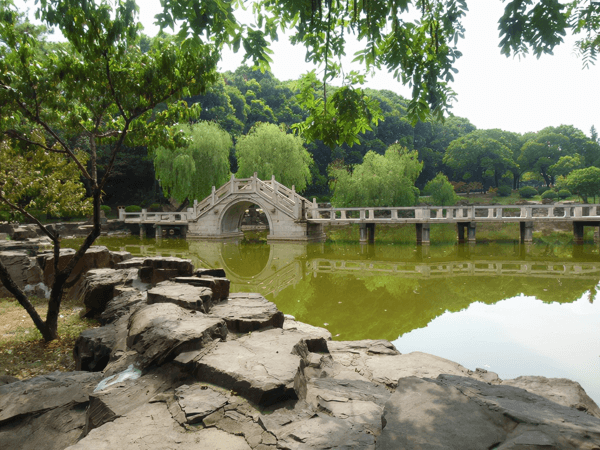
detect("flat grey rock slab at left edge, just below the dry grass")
[0,372,102,425]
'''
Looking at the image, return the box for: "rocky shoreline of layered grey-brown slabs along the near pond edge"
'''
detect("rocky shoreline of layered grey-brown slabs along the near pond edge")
[0,237,600,450]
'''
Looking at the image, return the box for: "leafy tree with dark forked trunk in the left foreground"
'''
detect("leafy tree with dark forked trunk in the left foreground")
[0,0,218,341]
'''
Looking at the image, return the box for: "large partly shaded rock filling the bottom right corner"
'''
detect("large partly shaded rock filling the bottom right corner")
[377,375,600,450]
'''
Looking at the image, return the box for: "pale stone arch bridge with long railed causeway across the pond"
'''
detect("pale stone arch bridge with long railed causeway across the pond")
[119,174,600,244]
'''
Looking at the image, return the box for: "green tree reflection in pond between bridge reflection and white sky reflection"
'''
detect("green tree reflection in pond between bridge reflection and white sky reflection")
[276,274,598,340]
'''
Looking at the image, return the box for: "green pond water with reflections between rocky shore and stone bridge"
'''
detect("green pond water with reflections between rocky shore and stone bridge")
[64,227,600,403]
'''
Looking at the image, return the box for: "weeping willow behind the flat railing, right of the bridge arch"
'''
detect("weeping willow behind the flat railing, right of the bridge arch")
[329,144,423,207]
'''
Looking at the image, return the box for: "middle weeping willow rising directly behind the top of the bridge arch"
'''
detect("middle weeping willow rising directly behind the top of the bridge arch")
[235,123,313,192]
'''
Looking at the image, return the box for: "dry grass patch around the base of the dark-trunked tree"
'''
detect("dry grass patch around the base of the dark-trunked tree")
[0,298,99,379]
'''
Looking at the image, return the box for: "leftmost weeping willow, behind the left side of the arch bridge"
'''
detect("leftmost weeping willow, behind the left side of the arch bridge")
[154,122,233,202]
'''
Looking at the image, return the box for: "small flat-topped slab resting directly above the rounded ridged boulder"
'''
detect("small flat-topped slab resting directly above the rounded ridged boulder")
[148,281,213,313]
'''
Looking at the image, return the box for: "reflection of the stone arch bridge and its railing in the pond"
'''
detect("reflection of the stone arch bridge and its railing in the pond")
[121,241,600,297]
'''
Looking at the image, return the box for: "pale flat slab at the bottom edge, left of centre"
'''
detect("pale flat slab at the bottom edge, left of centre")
[67,402,250,450]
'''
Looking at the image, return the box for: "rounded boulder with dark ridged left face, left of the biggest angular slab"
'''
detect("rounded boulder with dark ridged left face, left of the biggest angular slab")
[127,303,227,368]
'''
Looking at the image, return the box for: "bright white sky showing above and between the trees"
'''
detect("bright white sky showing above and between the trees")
[17,0,600,135]
